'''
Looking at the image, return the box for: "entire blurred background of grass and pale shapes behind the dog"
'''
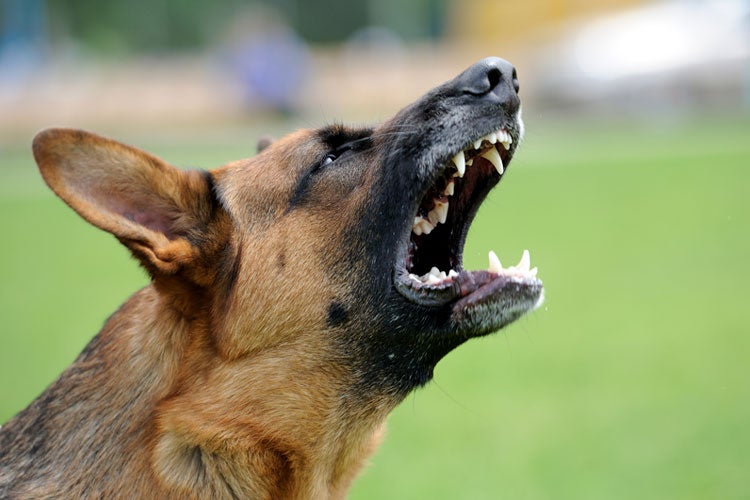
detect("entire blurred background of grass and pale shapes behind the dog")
[0,0,750,500]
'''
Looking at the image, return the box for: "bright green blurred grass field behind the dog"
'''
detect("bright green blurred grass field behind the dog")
[0,117,750,500]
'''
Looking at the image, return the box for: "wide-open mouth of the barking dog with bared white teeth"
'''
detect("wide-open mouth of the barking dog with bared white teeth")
[395,124,542,317]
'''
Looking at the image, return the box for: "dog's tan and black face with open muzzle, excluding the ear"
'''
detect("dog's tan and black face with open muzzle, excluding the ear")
[206,60,543,397]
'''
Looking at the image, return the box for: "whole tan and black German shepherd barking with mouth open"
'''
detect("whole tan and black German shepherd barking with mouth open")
[0,58,543,499]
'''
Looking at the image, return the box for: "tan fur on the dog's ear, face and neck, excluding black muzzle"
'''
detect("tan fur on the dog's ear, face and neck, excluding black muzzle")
[0,130,395,498]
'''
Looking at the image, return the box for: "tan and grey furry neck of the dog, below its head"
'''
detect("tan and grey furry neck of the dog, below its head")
[0,285,395,498]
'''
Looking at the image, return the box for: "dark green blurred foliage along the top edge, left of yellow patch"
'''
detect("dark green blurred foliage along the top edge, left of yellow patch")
[7,0,450,53]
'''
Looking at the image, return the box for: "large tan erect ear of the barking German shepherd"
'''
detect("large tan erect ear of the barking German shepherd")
[33,129,226,274]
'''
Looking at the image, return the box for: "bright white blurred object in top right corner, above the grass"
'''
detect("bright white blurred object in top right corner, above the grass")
[537,0,750,111]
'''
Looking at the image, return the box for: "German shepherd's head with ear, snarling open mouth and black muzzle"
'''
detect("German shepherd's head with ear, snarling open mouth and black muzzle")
[34,58,543,399]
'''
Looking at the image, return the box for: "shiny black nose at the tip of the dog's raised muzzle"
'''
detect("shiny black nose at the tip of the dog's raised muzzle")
[457,57,519,105]
